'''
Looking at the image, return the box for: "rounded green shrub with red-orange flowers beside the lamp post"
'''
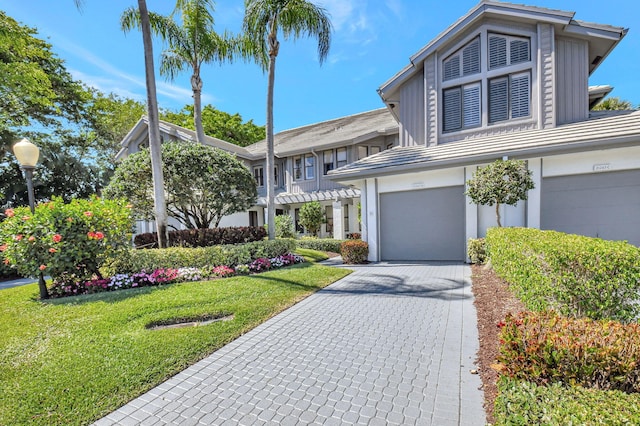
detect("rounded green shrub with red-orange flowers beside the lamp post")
[0,197,133,296]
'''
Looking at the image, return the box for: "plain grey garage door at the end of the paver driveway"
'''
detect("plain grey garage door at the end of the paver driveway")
[379,186,465,261]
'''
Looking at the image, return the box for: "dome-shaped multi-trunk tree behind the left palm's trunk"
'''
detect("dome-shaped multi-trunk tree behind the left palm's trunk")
[104,142,257,229]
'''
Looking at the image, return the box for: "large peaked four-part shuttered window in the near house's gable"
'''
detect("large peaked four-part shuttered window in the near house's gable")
[441,33,532,132]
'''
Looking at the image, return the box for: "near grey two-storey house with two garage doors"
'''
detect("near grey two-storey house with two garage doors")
[329,0,640,261]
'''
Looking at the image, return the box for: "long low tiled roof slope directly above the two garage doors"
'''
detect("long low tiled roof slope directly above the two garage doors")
[329,111,640,182]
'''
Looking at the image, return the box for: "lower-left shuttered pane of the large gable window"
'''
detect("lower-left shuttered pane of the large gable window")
[443,83,481,132]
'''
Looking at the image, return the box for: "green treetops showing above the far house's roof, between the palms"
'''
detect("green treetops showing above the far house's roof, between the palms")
[162,105,264,146]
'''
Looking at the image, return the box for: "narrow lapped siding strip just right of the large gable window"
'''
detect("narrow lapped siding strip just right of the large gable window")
[538,24,555,129]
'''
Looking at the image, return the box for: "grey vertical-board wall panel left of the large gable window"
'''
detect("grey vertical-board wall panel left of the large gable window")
[400,74,425,146]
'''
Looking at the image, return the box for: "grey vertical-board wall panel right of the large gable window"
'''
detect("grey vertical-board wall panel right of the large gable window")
[556,39,589,124]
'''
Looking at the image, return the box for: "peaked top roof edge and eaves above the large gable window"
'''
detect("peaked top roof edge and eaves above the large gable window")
[378,0,628,105]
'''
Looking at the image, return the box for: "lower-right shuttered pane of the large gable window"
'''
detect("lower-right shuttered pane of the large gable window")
[489,72,531,123]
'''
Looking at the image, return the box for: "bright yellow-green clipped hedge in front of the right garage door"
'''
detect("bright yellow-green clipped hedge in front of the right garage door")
[485,228,640,322]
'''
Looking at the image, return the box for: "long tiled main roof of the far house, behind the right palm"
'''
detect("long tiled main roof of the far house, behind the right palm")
[246,108,398,157]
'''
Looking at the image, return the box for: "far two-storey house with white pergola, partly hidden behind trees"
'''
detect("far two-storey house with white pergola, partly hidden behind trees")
[116,108,398,239]
